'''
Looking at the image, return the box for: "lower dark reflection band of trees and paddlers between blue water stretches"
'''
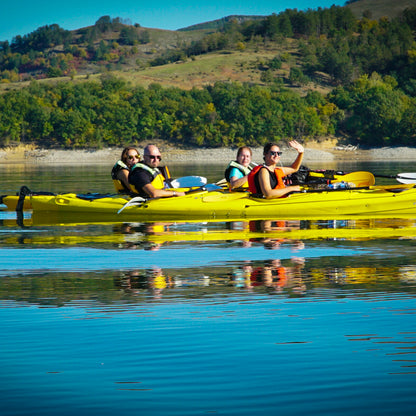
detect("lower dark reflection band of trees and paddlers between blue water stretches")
[0,256,416,306]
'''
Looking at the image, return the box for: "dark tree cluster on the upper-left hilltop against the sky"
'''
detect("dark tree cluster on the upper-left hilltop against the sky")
[0,16,149,82]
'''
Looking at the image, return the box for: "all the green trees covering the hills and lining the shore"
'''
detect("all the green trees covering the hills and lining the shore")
[0,6,416,147]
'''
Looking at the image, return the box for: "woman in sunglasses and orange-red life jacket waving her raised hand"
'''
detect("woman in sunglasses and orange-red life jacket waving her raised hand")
[248,140,304,199]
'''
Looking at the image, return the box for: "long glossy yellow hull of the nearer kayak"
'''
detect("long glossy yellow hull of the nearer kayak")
[30,185,416,221]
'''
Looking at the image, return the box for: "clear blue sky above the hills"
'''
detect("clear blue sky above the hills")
[0,0,345,42]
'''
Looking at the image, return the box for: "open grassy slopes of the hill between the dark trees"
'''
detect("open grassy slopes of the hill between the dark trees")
[0,0,416,92]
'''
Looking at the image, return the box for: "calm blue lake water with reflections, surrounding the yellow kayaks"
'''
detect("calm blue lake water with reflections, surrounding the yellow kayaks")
[0,163,416,416]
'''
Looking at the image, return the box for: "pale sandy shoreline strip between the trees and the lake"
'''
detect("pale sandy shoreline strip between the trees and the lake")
[0,143,416,165]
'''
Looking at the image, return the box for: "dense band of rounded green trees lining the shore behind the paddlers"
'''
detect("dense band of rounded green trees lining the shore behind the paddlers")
[0,77,342,147]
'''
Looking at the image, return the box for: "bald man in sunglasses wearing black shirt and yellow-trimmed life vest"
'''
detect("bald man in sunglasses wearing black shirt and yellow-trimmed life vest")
[129,144,185,198]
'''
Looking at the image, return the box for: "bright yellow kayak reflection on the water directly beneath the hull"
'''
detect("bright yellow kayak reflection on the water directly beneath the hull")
[0,212,416,250]
